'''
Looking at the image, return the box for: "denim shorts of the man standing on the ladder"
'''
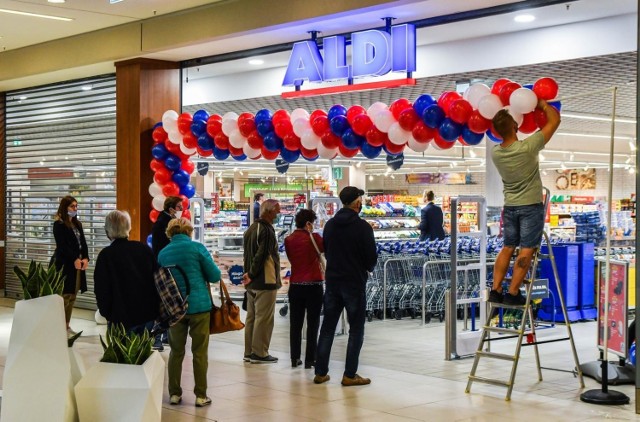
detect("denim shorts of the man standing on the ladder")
[502,203,544,248]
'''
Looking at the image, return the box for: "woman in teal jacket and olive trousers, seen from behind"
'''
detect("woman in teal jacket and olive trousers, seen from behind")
[158,218,221,407]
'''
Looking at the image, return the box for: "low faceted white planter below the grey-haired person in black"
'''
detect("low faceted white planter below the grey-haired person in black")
[75,352,165,422]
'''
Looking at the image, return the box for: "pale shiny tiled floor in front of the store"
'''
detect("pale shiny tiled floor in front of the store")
[0,299,640,422]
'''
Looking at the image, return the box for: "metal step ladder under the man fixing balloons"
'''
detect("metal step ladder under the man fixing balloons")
[465,232,584,401]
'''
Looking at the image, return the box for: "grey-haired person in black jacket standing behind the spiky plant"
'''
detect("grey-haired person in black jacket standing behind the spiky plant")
[94,210,160,334]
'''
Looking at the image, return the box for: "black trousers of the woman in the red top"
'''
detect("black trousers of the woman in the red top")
[289,283,322,363]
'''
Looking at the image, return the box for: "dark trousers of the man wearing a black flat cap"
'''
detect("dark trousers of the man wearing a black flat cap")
[315,286,367,378]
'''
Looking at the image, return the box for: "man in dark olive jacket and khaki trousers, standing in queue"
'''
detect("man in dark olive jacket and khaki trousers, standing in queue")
[242,199,282,363]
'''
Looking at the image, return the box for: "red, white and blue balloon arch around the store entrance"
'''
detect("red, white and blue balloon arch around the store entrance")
[149,77,560,221]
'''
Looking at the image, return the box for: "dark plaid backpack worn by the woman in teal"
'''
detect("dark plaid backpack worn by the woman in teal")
[152,265,191,334]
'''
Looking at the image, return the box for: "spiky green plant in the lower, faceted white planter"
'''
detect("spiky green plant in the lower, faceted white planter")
[100,324,154,365]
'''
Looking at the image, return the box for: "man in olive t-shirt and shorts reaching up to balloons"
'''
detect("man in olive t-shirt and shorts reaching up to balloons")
[489,100,560,305]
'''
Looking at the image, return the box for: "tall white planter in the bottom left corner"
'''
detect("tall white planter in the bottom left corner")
[0,295,78,422]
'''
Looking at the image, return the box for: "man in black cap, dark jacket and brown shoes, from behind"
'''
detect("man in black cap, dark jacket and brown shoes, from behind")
[313,186,378,386]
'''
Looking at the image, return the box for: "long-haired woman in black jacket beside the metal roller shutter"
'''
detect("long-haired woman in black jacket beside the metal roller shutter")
[51,195,89,335]
